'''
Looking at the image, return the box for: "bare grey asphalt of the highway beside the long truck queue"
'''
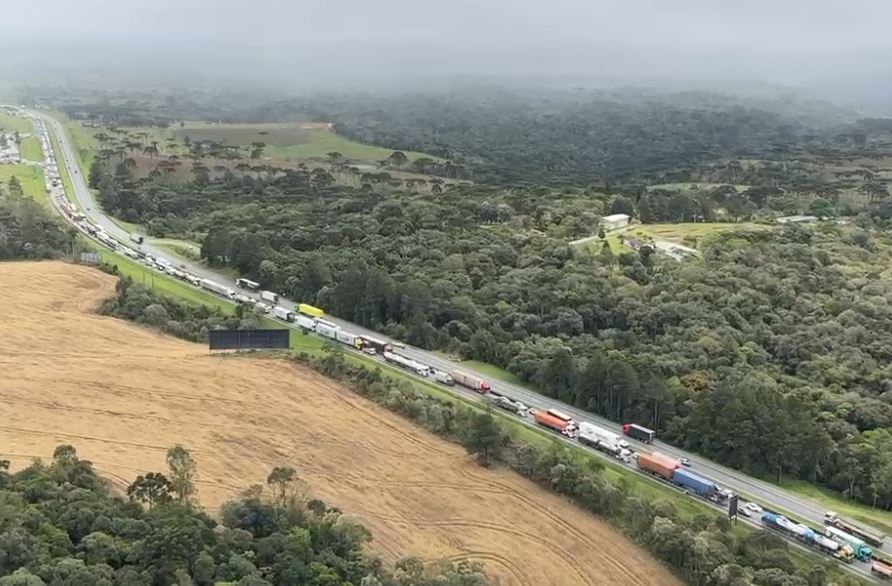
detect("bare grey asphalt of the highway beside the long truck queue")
[28,111,880,578]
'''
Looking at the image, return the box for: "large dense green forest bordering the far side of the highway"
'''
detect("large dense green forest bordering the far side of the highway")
[82,148,892,508]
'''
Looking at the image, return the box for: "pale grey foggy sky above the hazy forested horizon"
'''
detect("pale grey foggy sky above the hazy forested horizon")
[0,0,892,102]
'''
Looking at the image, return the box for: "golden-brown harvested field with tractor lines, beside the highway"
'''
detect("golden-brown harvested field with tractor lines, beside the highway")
[0,263,679,586]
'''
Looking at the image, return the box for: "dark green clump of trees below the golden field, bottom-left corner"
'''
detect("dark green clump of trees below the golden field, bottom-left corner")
[0,445,487,586]
